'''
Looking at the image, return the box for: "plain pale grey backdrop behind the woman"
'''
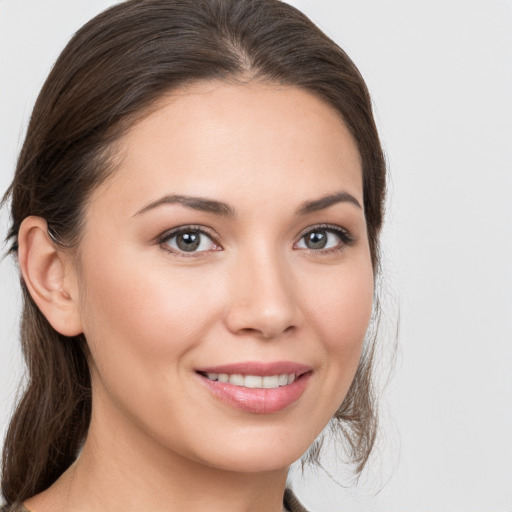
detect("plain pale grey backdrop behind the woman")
[0,0,512,512]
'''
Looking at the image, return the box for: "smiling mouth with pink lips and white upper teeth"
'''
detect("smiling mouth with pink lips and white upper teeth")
[196,362,313,414]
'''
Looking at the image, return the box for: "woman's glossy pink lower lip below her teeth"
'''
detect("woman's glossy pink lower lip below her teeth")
[198,373,311,414]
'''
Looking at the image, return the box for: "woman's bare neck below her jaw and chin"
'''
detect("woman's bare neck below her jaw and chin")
[42,400,288,512]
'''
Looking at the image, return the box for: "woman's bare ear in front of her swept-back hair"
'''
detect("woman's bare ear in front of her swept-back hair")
[18,216,82,336]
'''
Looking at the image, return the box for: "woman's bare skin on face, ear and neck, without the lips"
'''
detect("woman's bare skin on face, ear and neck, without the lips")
[20,82,373,512]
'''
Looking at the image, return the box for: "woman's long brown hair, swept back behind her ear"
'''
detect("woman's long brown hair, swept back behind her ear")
[2,0,385,505]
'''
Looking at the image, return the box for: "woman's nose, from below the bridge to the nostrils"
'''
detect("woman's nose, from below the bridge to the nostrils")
[226,251,301,339]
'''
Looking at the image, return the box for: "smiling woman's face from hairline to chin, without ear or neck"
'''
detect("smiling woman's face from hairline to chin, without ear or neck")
[77,82,373,472]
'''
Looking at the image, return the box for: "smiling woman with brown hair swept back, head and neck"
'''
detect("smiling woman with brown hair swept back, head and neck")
[2,0,385,512]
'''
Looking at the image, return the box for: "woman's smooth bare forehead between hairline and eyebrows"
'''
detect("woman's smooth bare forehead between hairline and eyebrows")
[89,82,362,216]
